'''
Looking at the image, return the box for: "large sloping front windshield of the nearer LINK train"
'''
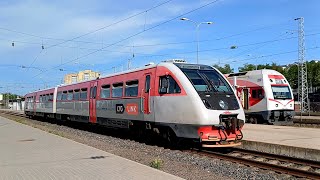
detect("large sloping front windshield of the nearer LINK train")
[181,69,233,93]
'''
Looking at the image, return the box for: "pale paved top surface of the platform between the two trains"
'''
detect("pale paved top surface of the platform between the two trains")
[243,124,320,150]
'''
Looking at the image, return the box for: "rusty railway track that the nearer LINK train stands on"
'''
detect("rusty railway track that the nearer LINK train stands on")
[0,110,320,179]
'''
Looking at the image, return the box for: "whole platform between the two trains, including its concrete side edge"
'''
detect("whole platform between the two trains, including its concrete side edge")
[242,124,320,161]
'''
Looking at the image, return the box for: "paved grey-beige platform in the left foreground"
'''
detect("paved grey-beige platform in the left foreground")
[0,117,181,180]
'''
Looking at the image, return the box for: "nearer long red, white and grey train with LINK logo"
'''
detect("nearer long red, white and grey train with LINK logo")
[25,60,245,147]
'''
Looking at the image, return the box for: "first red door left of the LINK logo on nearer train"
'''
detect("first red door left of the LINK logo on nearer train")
[89,81,98,123]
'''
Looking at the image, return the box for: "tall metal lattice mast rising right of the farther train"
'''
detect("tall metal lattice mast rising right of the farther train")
[294,17,309,113]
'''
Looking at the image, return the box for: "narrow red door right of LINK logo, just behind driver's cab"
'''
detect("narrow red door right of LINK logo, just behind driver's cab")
[142,72,153,121]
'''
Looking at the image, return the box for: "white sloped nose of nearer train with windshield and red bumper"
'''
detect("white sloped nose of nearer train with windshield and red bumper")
[175,63,245,148]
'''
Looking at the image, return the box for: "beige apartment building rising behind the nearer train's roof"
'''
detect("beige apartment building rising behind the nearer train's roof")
[63,70,100,84]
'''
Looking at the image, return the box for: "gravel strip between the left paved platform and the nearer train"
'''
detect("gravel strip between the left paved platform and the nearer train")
[0,114,294,180]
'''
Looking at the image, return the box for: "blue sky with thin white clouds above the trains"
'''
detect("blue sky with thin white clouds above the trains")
[0,0,320,95]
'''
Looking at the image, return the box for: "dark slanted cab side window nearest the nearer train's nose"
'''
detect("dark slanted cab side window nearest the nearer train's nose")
[159,76,181,94]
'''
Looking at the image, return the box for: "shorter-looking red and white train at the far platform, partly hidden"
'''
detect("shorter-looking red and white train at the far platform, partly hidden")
[226,69,295,125]
